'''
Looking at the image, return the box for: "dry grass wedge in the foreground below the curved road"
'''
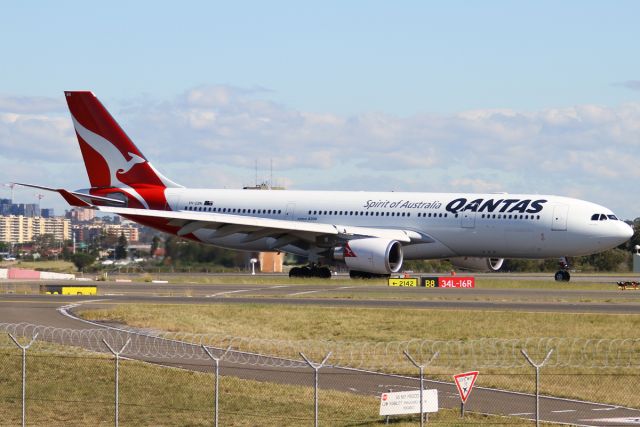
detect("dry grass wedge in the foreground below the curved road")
[0,345,530,427]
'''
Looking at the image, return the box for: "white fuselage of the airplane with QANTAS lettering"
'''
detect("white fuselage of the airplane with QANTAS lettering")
[165,188,632,259]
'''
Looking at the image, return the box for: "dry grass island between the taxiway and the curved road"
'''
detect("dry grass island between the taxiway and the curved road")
[80,304,640,407]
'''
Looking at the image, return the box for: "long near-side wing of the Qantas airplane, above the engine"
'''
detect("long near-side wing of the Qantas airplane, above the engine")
[96,206,433,249]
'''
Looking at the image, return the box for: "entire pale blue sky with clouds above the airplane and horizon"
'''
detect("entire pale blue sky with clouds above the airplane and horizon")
[0,1,640,218]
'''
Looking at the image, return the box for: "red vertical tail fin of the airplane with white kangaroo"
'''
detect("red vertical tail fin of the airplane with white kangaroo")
[65,91,180,207]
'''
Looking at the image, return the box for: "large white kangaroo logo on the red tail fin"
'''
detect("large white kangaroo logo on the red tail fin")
[71,116,149,209]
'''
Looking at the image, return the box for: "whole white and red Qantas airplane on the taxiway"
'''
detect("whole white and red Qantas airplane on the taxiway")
[20,91,633,281]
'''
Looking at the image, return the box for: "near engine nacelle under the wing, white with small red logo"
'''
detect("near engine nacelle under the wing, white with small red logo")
[333,237,403,274]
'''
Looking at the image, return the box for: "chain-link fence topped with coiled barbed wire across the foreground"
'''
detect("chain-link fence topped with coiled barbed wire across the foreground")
[0,324,640,426]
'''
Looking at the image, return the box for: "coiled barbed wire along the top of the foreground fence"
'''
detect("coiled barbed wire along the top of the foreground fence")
[0,323,640,372]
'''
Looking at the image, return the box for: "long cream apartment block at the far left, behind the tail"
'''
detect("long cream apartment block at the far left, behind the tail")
[0,215,71,243]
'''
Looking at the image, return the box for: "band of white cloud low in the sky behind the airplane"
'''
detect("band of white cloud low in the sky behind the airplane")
[0,85,640,221]
